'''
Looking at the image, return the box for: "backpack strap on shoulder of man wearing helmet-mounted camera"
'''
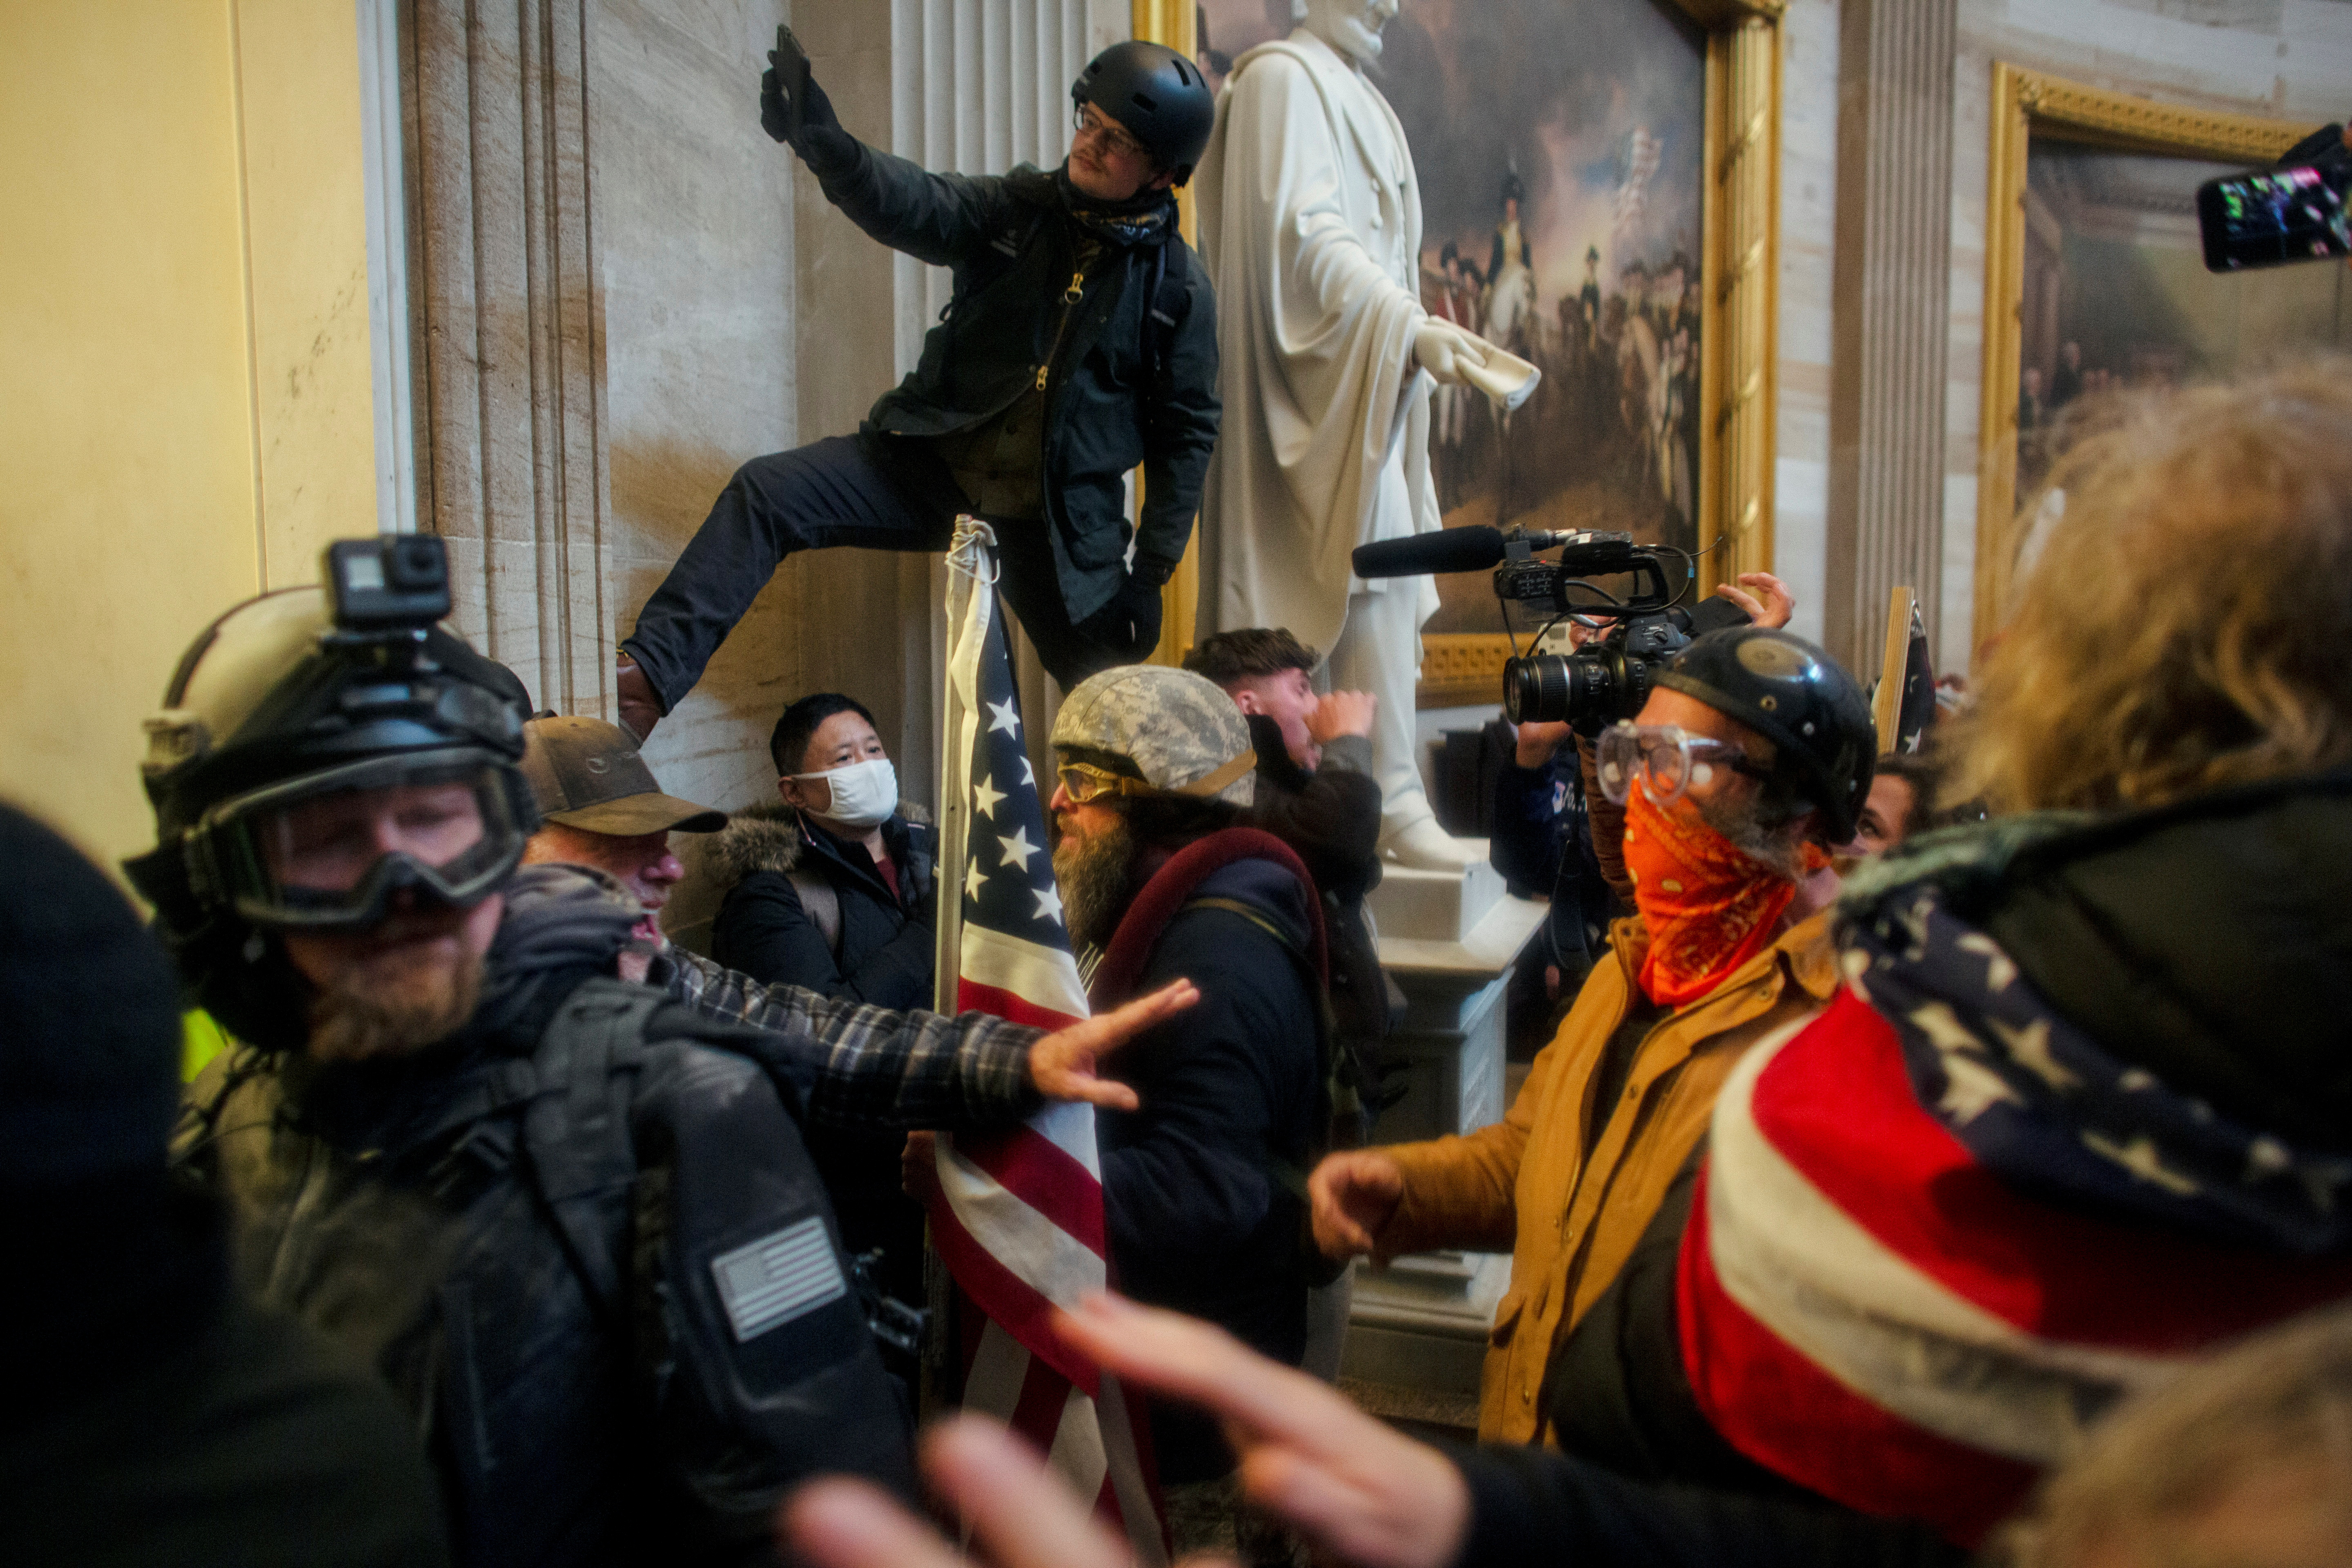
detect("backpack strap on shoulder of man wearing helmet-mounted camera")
[522,978,668,1316]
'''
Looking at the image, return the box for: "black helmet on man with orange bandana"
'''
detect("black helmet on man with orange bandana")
[1656,625,1879,844]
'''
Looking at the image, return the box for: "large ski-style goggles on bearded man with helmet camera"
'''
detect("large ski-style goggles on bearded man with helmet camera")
[193,748,529,931]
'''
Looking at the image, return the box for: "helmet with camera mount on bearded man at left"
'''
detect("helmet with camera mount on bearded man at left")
[122,538,539,1049]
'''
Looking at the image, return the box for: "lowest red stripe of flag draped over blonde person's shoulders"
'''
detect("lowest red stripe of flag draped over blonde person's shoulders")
[1675,1168,2034,1547]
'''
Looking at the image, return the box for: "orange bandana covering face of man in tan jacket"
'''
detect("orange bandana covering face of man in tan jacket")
[1625,783,1828,1006]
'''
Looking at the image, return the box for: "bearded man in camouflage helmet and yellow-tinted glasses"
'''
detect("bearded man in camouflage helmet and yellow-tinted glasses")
[1044,665,1327,1563]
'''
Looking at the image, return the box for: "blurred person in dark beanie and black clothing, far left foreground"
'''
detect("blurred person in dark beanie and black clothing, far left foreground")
[0,806,449,1568]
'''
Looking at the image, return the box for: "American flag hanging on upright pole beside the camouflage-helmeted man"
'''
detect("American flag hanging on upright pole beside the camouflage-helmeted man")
[931,517,1167,1568]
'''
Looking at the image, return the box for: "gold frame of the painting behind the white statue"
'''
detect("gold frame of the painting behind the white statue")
[1134,0,1788,708]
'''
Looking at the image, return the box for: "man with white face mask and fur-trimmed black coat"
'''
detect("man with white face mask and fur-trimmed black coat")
[710,691,938,1307]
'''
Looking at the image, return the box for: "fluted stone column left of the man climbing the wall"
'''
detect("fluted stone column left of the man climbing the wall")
[409,0,614,715]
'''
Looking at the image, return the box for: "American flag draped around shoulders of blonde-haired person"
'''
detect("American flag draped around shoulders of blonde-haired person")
[1675,959,2352,1547]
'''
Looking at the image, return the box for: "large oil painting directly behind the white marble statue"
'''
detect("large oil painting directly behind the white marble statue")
[1200,0,1708,633]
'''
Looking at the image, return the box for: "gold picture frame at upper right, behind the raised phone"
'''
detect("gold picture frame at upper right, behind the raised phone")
[1971,61,2312,646]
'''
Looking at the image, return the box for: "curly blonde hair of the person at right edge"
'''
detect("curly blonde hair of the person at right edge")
[1938,360,2352,811]
